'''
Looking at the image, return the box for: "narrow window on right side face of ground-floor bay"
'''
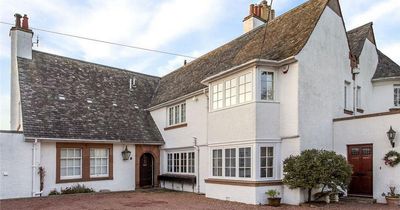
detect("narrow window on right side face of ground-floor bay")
[260,147,274,178]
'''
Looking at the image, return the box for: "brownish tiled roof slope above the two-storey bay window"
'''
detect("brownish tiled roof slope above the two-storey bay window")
[150,0,329,106]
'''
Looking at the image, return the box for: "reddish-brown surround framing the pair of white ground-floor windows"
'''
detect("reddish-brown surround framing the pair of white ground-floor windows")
[56,143,113,183]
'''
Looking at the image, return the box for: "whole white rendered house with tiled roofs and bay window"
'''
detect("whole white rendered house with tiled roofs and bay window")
[0,0,400,204]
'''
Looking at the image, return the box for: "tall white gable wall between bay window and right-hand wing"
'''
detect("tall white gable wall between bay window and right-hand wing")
[296,7,352,150]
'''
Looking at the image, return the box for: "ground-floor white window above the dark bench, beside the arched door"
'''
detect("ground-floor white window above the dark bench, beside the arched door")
[167,152,195,174]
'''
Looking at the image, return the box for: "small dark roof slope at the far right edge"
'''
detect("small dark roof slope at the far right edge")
[372,50,400,79]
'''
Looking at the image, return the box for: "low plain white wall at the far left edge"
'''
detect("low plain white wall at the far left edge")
[0,133,40,199]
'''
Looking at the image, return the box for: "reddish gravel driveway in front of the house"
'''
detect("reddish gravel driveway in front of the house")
[0,190,394,210]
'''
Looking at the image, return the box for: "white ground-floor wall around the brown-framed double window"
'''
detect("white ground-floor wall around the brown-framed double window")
[40,142,135,195]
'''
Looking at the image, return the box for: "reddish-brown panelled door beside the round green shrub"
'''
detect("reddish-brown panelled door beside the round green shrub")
[347,144,373,196]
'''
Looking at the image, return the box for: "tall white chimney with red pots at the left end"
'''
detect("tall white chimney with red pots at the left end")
[10,14,33,131]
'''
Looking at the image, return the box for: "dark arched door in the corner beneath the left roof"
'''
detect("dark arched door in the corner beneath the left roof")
[140,153,153,187]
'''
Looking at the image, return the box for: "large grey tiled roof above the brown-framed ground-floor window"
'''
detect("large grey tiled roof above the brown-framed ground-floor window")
[18,51,163,144]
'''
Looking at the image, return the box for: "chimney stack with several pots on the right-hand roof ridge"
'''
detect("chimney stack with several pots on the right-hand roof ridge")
[243,0,275,33]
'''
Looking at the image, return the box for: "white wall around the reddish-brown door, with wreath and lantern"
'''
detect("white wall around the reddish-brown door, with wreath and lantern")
[334,114,400,203]
